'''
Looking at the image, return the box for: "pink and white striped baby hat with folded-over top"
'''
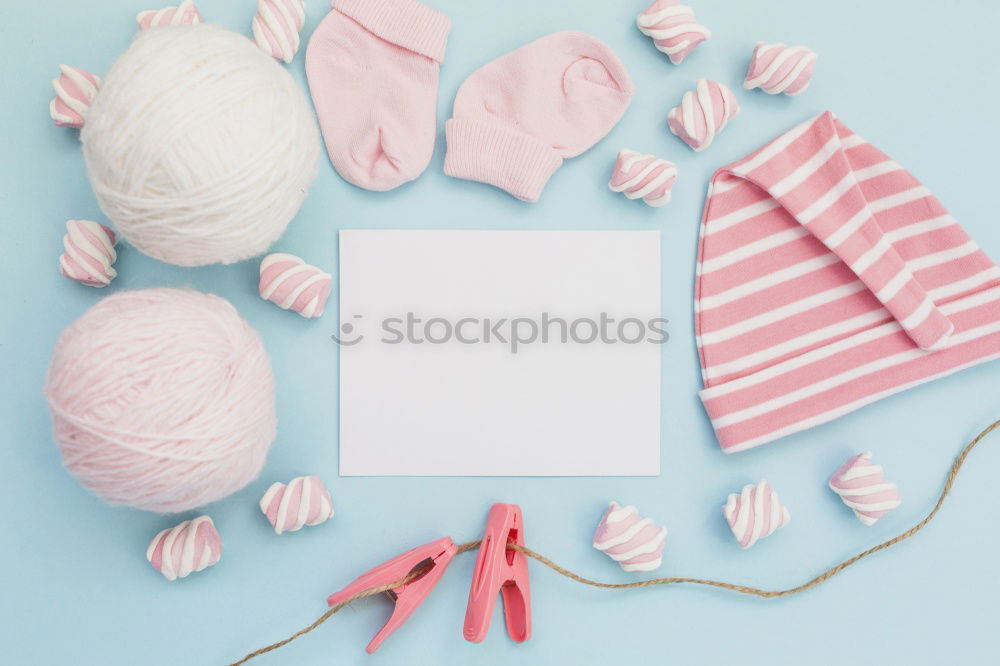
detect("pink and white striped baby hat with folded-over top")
[695,112,1000,452]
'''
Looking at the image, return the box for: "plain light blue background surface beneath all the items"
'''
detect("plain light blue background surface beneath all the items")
[0,0,1000,666]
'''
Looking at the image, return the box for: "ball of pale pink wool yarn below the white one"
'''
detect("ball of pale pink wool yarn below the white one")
[45,289,277,512]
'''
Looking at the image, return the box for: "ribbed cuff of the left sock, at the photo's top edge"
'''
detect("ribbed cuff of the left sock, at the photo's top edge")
[333,0,451,63]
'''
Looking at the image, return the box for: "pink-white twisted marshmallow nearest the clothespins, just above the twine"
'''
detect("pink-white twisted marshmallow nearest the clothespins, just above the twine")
[594,502,667,571]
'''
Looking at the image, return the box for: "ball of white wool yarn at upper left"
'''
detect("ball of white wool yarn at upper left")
[86,24,320,266]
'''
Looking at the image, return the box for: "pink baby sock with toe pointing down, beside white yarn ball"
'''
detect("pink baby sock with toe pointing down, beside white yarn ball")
[306,0,451,191]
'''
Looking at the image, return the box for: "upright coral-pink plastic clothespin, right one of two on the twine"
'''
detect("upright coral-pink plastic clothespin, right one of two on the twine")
[462,504,531,643]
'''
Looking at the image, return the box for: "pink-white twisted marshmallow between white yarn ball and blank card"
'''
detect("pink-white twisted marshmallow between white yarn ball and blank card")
[258,252,333,318]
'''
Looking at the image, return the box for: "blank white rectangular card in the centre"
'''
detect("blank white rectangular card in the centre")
[337,230,665,476]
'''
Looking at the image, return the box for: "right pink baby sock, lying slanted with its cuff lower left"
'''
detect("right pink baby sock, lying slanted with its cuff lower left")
[444,32,632,201]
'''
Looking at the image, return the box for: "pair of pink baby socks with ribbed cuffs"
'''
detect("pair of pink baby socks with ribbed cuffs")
[306,0,633,201]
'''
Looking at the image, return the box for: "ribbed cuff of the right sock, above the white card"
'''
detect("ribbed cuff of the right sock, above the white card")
[444,118,562,201]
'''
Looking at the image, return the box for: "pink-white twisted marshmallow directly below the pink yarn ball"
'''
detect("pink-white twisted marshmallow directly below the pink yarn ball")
[146,516,222,580]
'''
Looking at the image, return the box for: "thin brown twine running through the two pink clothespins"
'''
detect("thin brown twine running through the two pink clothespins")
[230,420,1000,666]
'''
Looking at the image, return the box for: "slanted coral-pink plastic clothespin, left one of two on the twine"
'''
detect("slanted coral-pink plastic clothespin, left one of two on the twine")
[326,537,457,654]
